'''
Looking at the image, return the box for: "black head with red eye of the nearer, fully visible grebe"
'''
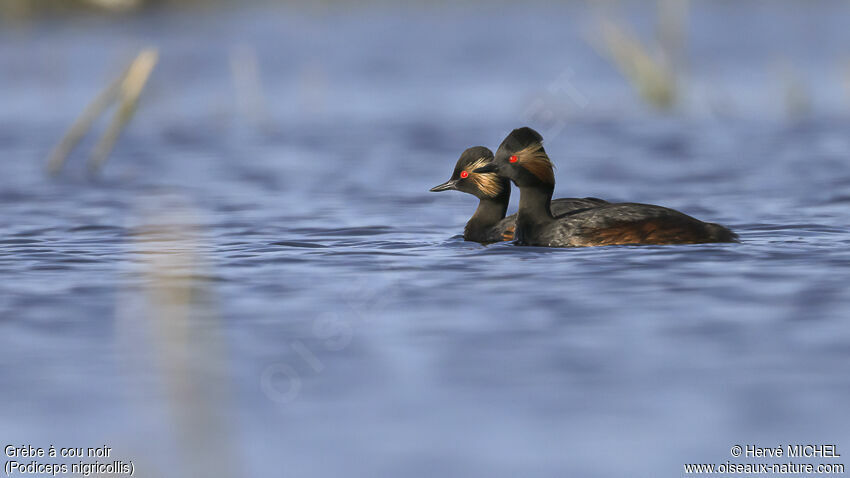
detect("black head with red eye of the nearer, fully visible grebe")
[474,127,555,187]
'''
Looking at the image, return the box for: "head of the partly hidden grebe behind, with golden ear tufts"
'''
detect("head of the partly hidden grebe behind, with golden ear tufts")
[431,146,510,199]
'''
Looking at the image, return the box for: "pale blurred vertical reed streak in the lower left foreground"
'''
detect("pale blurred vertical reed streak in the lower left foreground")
[132,204,239,478]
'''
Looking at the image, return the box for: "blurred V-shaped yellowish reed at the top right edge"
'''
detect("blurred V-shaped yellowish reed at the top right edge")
[592,0,688,110]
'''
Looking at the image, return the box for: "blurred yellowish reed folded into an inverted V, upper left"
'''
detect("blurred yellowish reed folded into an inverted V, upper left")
[47,48,159,175]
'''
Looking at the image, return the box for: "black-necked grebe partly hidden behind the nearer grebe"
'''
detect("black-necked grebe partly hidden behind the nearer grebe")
[431,146,608,243]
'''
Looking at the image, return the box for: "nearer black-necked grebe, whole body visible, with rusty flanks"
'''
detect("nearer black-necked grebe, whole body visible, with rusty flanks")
[473,128,738,247]
